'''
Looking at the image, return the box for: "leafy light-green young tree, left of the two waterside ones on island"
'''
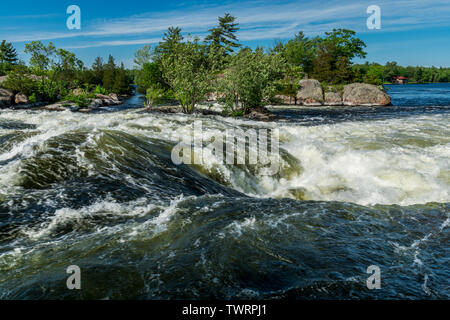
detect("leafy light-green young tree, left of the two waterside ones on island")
[161,39,213,113]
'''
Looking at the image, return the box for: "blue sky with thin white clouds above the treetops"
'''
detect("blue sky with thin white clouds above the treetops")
[0,0,450,67]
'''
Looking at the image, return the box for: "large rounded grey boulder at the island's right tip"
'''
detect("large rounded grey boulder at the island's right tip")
[343,83,391,106]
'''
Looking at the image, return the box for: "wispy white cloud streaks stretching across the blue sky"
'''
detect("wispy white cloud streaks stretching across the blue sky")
[0,0,450,48]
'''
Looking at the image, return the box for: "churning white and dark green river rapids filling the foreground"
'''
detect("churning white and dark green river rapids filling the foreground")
[0,84,450,299]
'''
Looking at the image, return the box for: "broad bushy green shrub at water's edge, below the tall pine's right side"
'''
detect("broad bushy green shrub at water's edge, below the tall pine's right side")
[218,48,286,112]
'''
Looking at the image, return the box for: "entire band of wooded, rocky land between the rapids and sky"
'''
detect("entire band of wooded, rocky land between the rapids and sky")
[0,14,450,116]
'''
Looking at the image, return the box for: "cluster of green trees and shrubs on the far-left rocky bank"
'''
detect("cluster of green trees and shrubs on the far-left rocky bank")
[0,40,133,102]
